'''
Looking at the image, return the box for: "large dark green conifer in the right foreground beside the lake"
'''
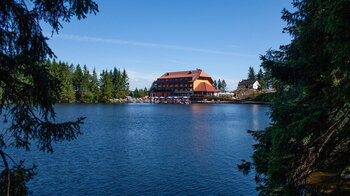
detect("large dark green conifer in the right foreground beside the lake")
[241,0,350,195]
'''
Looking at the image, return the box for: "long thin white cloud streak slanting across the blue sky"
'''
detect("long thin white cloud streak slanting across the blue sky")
[54,34,256,57]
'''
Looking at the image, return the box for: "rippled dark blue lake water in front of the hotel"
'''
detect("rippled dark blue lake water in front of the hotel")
[10,104,270,195]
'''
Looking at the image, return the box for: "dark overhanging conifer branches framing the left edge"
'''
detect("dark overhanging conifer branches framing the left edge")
[0,0,98,195]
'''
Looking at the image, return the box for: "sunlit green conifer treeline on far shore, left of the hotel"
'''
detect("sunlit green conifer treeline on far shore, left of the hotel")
[43,60,130,103]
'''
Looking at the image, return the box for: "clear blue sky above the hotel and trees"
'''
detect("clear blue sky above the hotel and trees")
[43,0,291,90]
